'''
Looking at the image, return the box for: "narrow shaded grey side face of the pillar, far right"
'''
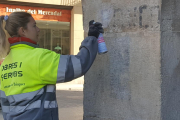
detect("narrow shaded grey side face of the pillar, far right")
[161,0,180,120]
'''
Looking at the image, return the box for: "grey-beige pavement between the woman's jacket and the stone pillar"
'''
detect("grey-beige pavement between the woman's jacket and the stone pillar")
[57,90,83,120]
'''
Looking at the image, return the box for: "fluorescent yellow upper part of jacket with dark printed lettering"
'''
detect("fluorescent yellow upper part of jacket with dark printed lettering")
[0,44,60,96]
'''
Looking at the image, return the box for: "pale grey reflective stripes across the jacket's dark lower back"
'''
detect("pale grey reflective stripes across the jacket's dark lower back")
[1,85,58,113]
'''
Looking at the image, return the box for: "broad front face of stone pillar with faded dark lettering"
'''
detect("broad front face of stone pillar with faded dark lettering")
[82,0,161,120]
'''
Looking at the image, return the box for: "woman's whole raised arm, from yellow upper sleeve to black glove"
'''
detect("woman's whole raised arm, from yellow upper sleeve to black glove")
[39,21,102,84]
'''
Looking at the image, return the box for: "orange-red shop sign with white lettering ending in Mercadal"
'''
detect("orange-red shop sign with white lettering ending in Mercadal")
[0,4,71,22]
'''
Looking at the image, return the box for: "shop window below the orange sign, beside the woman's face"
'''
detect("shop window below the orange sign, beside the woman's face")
[36,20,70,55]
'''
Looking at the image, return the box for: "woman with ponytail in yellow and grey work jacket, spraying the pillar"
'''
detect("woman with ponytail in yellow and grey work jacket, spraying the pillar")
[0,12,103,120]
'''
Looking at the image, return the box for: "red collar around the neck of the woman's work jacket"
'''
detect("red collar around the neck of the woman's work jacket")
[8,37,39,48]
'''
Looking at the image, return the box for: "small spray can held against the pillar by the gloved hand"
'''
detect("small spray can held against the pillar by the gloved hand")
[93,22,108,54]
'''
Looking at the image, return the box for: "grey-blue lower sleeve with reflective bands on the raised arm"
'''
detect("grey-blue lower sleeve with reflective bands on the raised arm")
[57,36,98,82]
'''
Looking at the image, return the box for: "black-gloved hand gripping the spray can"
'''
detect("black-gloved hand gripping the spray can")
[88,20,104,38]
